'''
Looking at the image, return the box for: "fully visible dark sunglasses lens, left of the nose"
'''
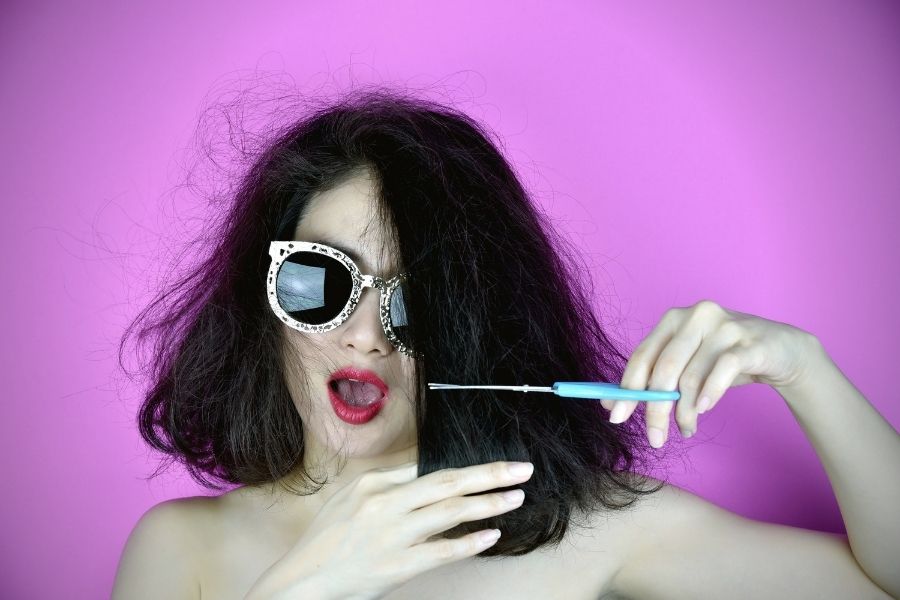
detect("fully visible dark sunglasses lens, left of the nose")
[275,252,353,325]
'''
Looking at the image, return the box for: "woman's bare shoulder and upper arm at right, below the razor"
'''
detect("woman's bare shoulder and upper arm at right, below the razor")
[608,476,889,600]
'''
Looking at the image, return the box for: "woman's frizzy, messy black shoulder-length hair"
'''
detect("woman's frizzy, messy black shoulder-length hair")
[120,87,662,557]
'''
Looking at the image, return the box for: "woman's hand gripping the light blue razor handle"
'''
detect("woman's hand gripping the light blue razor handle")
[601,300,819,448]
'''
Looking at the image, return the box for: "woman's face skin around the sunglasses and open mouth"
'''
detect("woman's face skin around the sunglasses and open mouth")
[284,169,416,462]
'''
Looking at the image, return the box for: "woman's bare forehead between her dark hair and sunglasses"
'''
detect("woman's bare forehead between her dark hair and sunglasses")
[294,174,397,276]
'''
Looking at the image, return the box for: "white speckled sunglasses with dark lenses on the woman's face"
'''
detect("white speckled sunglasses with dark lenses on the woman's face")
[267,241,421,358]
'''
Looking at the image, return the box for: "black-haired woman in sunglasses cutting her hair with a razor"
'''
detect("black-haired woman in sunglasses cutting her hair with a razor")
[113,90,900,599]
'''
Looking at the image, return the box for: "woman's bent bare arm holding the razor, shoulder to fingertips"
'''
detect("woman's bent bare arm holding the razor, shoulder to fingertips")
[603,300,900,598]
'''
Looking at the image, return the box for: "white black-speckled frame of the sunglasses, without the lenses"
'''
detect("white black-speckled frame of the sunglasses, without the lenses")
[266,240,422,358]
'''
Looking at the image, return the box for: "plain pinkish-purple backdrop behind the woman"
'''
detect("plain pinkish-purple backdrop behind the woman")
[0,0,900,598]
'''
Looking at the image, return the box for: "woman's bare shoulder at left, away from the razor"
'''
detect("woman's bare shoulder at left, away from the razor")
[112,496,214,600]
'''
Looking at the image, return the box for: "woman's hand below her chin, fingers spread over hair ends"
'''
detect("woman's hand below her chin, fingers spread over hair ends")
[247,461,531,600]
